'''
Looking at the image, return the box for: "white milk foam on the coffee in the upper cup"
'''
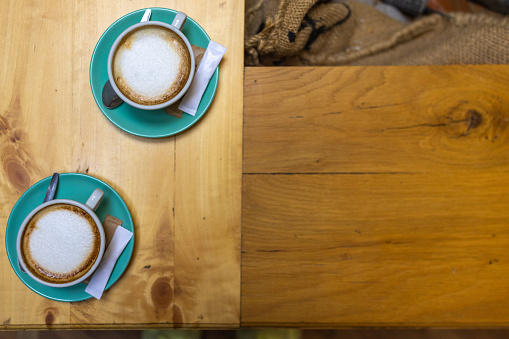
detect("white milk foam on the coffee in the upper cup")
[114,28,187,100]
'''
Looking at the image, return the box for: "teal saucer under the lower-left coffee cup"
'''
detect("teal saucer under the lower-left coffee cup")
[5,173,134,301]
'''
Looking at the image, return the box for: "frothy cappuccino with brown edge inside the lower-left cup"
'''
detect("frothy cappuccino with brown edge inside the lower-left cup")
[21,203,101,284]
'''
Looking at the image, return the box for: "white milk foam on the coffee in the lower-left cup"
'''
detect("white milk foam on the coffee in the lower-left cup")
[29,209,95,274]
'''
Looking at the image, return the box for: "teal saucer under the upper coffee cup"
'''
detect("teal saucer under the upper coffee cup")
[90,8,219,138]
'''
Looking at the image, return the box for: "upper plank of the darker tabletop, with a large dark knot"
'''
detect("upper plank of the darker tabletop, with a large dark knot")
[243,65,509,173]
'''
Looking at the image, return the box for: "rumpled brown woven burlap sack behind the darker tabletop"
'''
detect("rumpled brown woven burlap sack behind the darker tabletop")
[245,0,509,66]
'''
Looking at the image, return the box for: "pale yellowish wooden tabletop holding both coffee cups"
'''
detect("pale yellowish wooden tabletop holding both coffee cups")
[0,0,244,329]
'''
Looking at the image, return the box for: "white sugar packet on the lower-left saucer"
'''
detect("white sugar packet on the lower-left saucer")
[85,226,133,299]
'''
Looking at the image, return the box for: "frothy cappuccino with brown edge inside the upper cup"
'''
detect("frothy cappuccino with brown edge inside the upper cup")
[111,25,191,105]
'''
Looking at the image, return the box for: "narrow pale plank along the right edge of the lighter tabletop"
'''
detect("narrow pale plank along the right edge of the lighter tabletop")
[175,1,244,327]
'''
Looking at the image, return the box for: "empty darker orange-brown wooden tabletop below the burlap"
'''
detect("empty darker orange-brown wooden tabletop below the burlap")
[241,66,509,328]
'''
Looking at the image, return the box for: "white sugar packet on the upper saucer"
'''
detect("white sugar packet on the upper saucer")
[179,41,226,116]
